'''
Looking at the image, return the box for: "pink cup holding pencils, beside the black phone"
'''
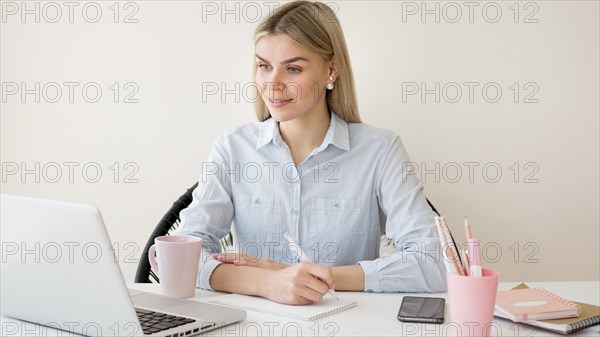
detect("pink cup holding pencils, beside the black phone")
[447,269,500,336]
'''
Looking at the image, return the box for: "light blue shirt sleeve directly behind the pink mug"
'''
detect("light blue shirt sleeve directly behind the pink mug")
[173,135,234,290]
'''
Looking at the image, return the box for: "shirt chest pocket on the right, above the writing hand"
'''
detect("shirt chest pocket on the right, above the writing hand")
[309,199,360,263]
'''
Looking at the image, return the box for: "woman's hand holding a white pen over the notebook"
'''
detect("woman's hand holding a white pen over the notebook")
[261,262,334,305]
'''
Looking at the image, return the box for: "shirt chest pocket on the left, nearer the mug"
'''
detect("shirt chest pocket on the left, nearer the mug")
[234,194,281,244]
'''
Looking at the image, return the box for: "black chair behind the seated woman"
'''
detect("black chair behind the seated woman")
[135,183,452,283]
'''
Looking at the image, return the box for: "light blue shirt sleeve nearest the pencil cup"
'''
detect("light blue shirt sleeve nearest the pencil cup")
[359,134,446,292]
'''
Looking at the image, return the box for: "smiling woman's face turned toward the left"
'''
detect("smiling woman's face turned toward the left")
[256,34,336,122]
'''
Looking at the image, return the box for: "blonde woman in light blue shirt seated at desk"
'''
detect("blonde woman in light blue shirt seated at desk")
[177,1,445,304]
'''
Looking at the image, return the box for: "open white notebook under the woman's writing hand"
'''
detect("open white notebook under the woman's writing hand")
[208,294,357,321]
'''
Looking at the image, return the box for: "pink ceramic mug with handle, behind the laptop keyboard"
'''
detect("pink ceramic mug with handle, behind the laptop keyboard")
[148,235,202,298]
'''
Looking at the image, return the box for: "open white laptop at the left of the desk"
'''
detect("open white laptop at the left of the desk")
[0,194,246,337]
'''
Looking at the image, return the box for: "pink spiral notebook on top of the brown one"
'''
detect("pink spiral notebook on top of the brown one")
[495,288,581,322]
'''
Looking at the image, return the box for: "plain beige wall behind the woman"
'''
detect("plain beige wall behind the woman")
[0,1,600,281]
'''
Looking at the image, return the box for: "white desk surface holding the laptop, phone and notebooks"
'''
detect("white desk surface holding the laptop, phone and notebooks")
[0,281,600,337]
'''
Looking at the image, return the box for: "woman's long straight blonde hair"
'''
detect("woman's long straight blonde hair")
[254,1,361,123]
